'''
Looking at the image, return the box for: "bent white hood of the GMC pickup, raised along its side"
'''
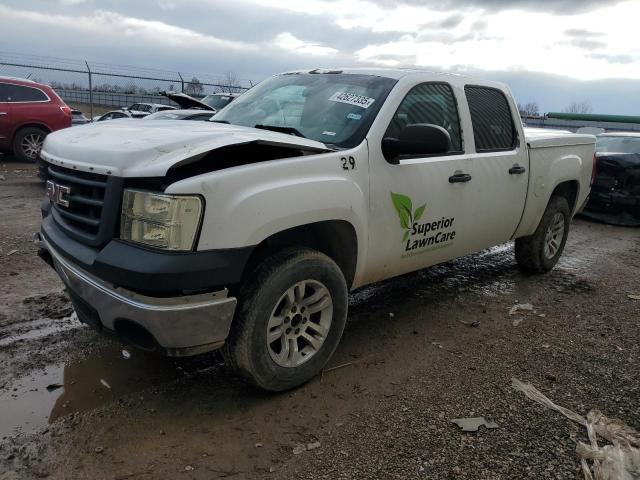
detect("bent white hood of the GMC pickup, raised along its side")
[40,119,329,177]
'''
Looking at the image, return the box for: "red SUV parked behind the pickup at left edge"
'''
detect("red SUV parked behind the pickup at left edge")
[0,77,72,162]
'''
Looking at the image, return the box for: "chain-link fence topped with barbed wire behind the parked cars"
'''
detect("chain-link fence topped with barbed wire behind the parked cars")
[0,52,253,117]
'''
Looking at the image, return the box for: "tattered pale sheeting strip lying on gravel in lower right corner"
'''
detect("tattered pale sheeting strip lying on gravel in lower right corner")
[511,378,640,480]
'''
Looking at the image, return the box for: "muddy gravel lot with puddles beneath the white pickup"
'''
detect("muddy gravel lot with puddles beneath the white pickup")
[0,157,640,480]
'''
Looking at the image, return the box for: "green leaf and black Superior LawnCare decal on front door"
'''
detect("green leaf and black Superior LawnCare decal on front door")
[391,192,456,258]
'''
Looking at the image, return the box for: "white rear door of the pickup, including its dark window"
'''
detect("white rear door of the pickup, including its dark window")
[464,85,529,251]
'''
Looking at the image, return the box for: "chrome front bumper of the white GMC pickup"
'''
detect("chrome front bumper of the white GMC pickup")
[34,233,237,356]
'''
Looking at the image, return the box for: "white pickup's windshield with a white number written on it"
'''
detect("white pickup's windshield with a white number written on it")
[212,73,396,148]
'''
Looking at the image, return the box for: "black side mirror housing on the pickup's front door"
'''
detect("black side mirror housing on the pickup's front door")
[382,123,451,164]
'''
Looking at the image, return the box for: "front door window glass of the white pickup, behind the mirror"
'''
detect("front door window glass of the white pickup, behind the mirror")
[385,83,463,153]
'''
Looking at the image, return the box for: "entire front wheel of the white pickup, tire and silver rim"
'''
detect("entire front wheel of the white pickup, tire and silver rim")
[225,248,348,391]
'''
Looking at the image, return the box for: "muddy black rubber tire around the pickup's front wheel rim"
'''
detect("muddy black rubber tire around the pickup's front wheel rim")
[223,248,348,391]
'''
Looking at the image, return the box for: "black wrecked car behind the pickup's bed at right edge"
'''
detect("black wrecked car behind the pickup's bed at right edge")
[583,132,640,226]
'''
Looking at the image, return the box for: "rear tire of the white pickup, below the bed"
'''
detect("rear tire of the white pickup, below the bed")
[515,196,571,273]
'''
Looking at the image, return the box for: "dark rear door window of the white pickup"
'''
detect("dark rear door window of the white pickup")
[464,86,517,152]
